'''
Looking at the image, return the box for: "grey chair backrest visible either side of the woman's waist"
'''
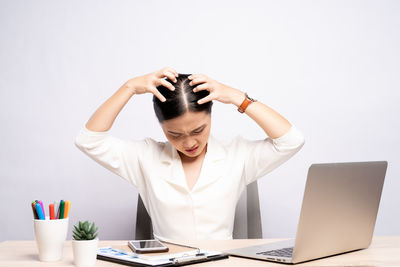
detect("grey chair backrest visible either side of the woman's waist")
[135,181,262,240]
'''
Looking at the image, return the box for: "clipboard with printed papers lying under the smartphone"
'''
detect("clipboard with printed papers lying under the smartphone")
[97,246,229,267]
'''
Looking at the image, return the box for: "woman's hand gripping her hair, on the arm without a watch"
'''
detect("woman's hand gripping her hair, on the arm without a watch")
[124,67,178,102]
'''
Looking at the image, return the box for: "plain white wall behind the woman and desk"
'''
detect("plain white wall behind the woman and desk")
[0,0,400,241]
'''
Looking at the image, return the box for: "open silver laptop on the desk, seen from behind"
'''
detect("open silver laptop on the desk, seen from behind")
[226,161,387,264]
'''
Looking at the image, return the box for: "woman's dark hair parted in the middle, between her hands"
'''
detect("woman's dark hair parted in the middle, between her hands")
[153,73,213,123]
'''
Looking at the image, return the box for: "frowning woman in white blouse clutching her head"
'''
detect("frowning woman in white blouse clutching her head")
[75,67,304,240]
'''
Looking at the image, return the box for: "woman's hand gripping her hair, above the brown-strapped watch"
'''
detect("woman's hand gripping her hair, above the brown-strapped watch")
[188,74,244,105]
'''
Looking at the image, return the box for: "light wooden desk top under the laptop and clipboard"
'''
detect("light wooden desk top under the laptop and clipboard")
[0,236,400,267]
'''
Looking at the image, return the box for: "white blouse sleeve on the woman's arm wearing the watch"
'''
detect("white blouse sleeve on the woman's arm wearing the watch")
[242,126,305,184]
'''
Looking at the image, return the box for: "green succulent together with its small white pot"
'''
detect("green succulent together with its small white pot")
[72,221,99,267]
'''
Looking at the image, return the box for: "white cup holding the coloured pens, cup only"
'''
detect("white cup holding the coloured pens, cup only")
[33,217,69,261]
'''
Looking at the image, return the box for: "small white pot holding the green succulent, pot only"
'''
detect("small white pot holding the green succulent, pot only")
[72,238,99,267]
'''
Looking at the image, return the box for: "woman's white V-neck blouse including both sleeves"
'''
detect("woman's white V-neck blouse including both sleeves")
[75,126,304,240]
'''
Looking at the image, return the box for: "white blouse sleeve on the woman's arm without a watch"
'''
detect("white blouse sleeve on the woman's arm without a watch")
[74,126,149,186]
